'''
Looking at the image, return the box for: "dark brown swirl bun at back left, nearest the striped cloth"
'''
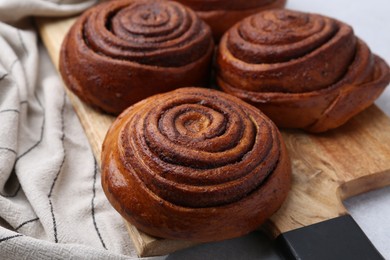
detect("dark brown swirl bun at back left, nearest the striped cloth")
[60,0,214,114]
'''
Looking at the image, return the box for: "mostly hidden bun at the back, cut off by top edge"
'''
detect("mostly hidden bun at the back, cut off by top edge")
[177,0,286,41]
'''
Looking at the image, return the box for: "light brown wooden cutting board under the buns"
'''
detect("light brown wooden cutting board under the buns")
[37,15,390,256]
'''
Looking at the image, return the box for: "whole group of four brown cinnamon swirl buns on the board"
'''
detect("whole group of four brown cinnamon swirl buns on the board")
[60,0,390,242]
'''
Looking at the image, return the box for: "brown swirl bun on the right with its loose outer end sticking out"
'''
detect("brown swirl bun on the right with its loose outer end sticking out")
[217,10,390,132]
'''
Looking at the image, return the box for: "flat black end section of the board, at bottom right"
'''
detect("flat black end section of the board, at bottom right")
[276,215,384,260]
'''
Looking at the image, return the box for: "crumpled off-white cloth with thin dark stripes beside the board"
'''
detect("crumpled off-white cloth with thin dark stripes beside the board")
[0,0,163,259]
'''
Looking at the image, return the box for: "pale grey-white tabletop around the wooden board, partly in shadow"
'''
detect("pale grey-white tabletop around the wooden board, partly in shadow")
[167,0,390,260]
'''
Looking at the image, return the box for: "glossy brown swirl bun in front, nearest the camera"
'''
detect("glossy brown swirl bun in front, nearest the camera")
[102,88,291,242]
